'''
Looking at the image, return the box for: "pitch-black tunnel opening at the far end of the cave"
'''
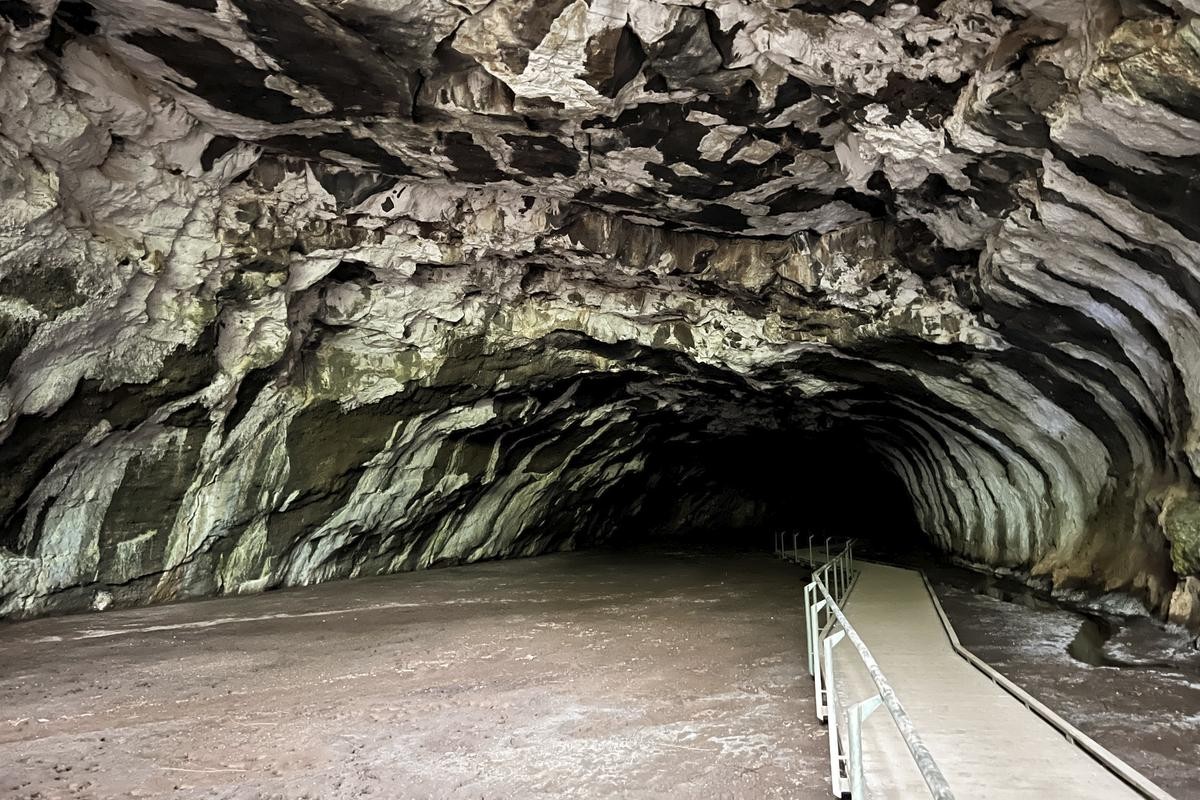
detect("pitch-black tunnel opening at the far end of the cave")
[606,425,931,555]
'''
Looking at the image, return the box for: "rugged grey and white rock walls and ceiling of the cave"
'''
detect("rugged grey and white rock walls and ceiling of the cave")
[0,0,1200,625]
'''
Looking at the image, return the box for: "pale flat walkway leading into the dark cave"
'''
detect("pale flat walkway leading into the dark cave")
[834,563,1141,800]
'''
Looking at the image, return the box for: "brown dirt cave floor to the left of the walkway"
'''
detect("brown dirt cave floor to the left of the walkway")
[0,551,828,799]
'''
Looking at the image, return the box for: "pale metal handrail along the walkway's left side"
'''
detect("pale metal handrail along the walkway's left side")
[804,540,954,800]
